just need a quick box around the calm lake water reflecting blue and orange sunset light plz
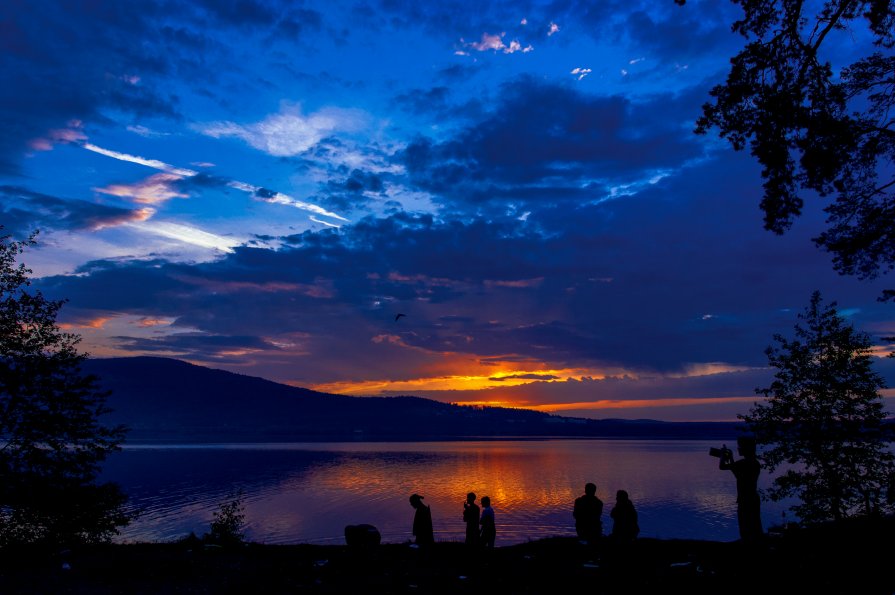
[104,440,782,545]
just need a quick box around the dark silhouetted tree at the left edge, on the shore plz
[0,228,127,544]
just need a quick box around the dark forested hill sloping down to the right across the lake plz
[84,357,736,442]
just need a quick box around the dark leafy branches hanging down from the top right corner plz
[676,0,895,284]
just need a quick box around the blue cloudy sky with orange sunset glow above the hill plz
[0,0,895,421]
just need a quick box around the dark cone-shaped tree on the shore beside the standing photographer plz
[739,292,893,522]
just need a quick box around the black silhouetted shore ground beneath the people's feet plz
[0,518,895,595]
